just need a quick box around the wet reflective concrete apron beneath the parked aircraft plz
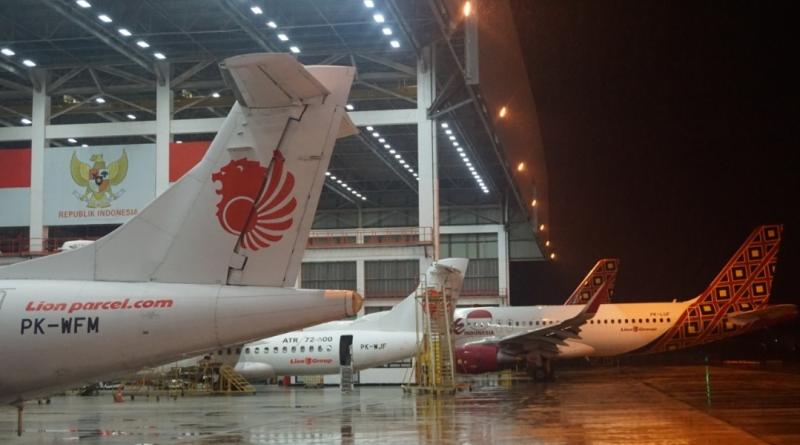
[0,366,800,445]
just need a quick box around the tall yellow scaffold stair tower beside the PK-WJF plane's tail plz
[404,276,456,394]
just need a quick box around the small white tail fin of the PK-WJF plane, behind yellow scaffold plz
[353,258,469,331]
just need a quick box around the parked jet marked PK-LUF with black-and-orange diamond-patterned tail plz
[455,225,798,378]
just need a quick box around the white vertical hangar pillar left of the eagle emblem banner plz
[28,69,50,251]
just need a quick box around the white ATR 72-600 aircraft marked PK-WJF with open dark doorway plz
[228,258,468,379]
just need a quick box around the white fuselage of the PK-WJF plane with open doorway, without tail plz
[235,322,418,379]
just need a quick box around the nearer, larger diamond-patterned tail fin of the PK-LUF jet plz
[647,224,783,352]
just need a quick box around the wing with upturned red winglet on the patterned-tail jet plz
[467,282,609,355]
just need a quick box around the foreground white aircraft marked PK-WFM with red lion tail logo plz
[0,54,361,403]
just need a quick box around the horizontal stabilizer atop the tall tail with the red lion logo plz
[222,54,330,108]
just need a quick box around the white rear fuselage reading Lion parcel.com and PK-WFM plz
[0,280,358,403]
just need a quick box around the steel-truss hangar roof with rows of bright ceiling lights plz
[0,0,546,234]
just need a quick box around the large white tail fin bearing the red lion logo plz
[0,54,354,286]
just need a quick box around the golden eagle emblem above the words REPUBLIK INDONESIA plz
[69,149,128,209]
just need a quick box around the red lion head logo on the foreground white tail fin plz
[211,150,297,250]
